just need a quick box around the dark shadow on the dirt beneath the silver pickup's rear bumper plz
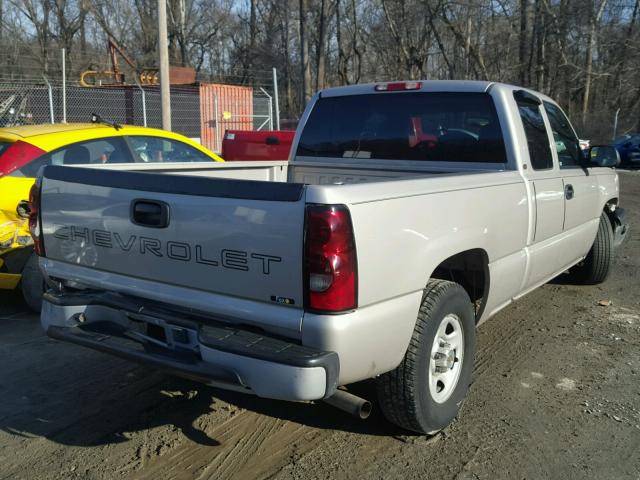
[0,290,407,452]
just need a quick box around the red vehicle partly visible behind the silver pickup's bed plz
[222,130,296,161]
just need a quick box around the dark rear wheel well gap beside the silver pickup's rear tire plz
[431,248,489,322]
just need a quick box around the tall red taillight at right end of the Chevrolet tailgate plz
[305,205,358,313]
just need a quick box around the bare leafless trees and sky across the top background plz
[0,0,640,142]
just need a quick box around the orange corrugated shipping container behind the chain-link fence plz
[200,83,253,153]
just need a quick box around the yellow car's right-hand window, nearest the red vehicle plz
[127,136,211,163]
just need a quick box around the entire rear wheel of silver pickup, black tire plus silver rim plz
[376,279,476,435]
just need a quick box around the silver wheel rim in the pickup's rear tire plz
[429,313,464,403]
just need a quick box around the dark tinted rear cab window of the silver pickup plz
[296,92,507,164]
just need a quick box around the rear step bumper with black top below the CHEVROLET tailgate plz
[41,292,340,401]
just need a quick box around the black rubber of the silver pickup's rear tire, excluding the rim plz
[376,280,476,434]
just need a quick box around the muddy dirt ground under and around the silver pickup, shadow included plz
[0,172,640,480]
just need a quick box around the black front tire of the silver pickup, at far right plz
[571,212,614,285]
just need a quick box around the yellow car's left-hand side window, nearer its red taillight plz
[20,137,131,177]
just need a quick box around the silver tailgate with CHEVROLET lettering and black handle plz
[41,166,304,311]
